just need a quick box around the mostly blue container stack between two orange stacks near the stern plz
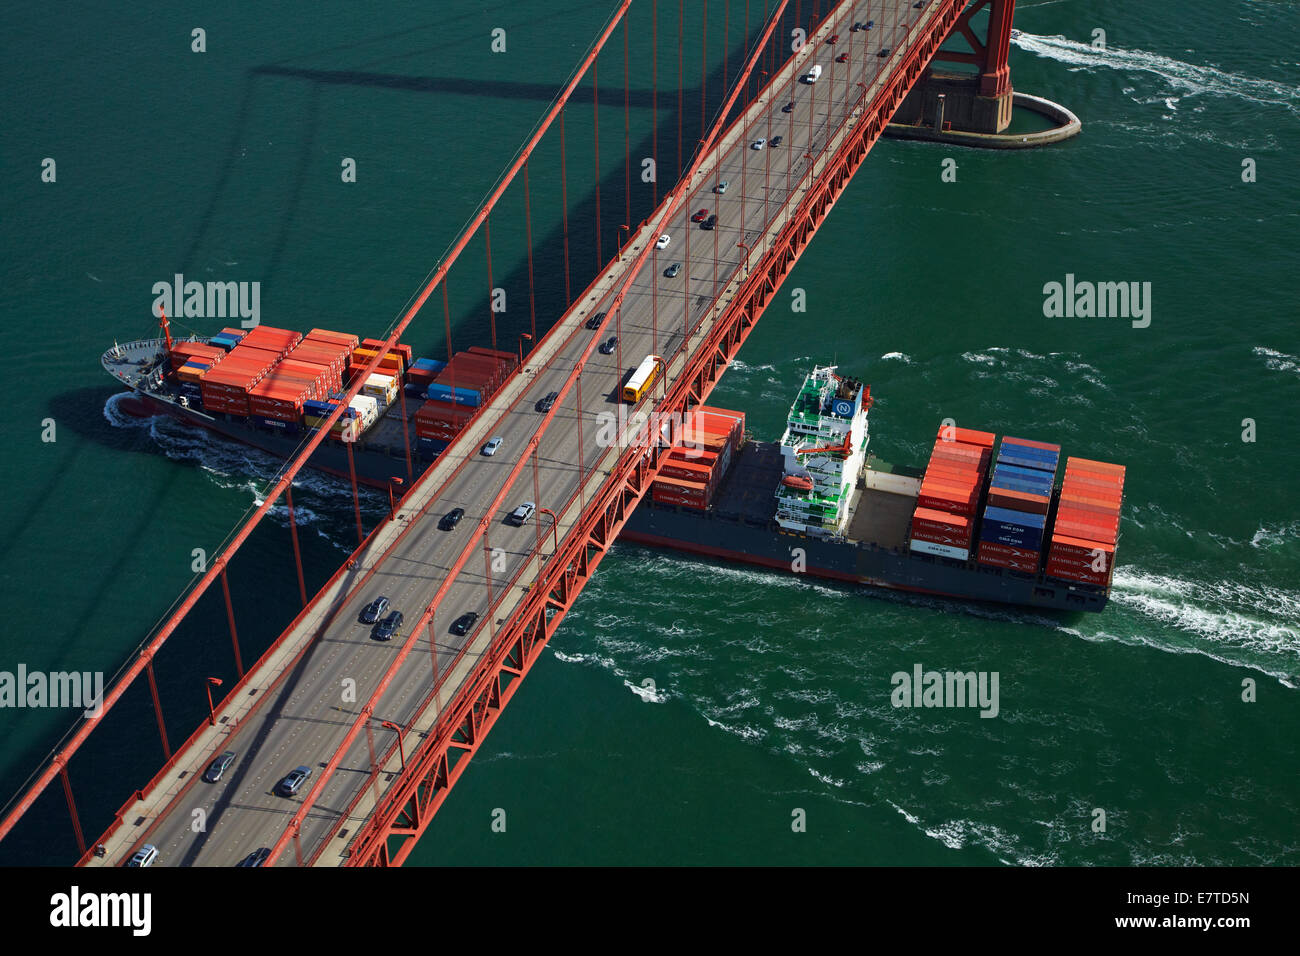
[976,437,1061,574]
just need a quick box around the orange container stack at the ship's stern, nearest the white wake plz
[1047,458,1125,587]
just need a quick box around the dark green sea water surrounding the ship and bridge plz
[0,0,1300,865]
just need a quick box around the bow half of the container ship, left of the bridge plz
[100,315,519,488]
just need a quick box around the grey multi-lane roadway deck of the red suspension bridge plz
[91,0,935,866]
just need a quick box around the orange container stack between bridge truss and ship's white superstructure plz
[650,405,745,511]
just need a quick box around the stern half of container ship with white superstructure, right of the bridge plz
[620,368,1125,611]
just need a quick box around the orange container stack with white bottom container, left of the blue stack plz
[909,425,995,561]
